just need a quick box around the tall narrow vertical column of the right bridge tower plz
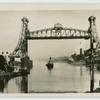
[88,16,96,92]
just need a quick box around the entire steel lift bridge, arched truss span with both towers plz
[0,16,100,92]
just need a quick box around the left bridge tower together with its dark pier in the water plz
[9,17,30,93]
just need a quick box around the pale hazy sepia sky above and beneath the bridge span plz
[0,10,100,57]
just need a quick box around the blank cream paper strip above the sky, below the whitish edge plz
[0,3,100,11]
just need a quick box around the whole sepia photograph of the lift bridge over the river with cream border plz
[0,5,100,94]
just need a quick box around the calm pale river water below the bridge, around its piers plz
[5,60,100,93]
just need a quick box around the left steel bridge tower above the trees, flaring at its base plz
[9,17,29,58]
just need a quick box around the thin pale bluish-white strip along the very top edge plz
[0,0,100,3]
